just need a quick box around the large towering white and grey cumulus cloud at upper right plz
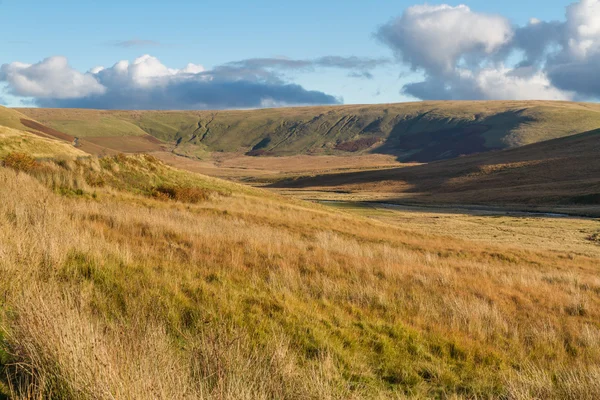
[376,0,600,100]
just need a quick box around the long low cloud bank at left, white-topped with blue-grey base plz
[0,55,339,109]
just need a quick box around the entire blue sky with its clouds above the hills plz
[0,0,600,109]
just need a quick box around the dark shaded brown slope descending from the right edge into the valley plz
[274,130,600,209]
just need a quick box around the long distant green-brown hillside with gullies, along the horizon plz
[21,101,600,161]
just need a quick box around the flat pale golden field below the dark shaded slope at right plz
[324,201,600,258]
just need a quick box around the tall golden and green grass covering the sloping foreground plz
[0,156,600,399]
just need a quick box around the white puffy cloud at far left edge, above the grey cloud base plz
[0,56,106,99]
